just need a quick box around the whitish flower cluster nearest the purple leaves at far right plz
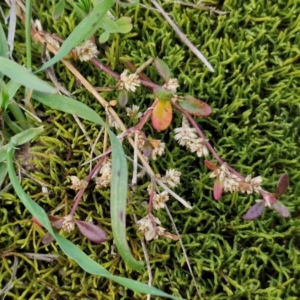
[210,163,262,194]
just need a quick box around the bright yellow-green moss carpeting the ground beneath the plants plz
[0,0,300,300]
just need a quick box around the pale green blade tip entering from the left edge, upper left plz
[0,57,56,94]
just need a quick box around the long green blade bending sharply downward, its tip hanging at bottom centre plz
[32,92,142,270]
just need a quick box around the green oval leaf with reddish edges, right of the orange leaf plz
[178,96,212,117]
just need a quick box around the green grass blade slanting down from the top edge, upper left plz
[38,0,114,72]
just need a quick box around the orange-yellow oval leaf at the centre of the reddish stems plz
[152,101,173,131]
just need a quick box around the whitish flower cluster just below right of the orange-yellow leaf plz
[174,117,209,157]
